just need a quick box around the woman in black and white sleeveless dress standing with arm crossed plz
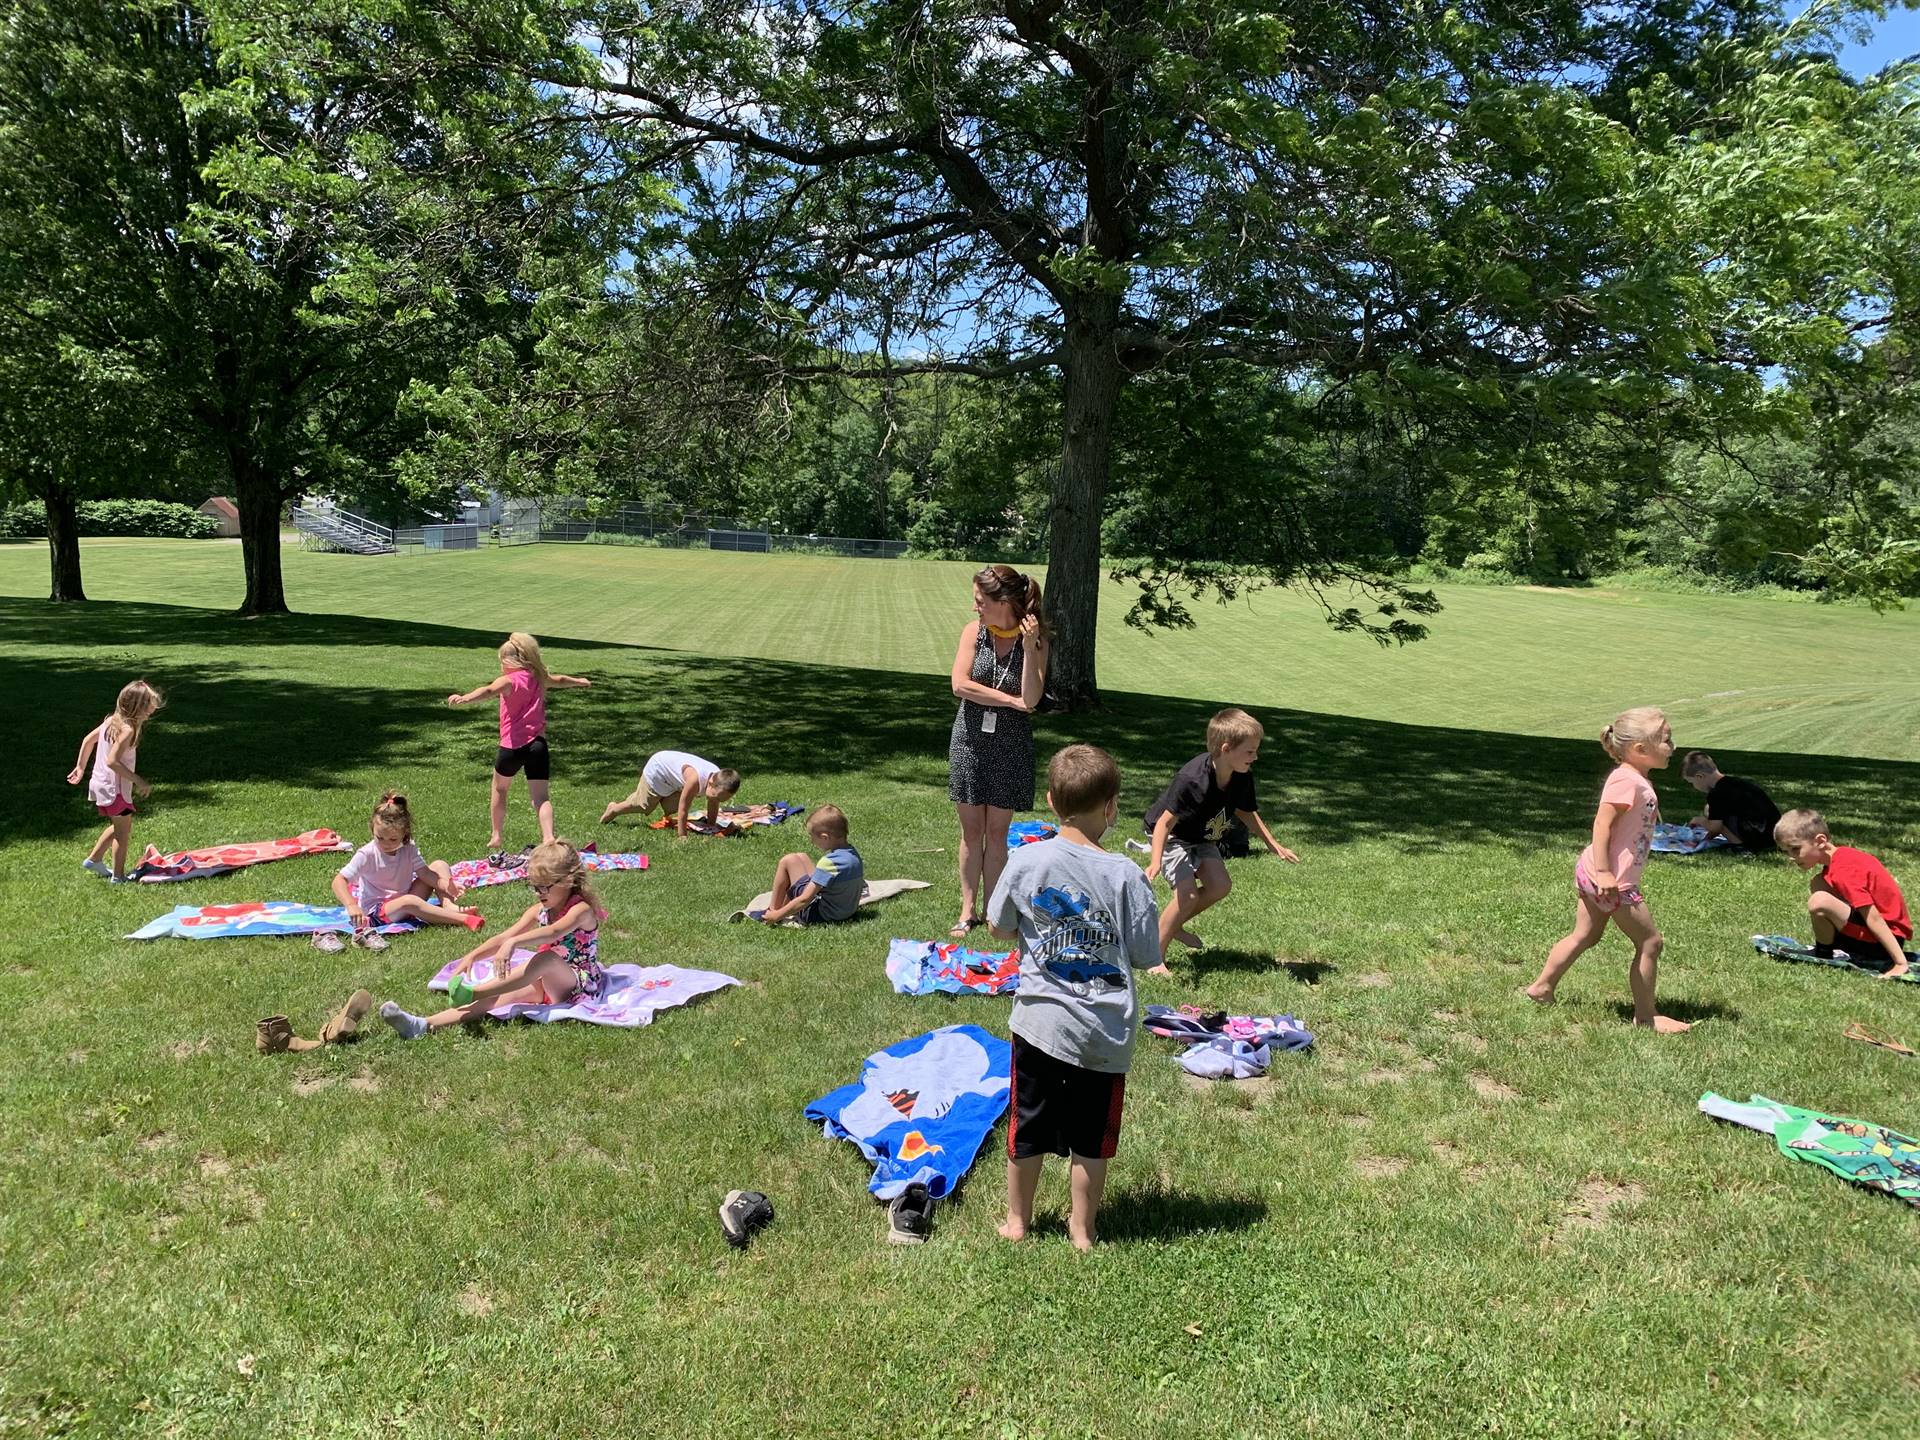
[947,564,1046,939]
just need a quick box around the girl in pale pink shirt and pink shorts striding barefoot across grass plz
[1526,705,1692,1035]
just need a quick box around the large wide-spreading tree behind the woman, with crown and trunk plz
[483,0,1904,703]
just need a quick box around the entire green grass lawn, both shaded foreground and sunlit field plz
[0,541,1920,1440]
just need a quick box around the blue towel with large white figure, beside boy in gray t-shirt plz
[806,1025,1014,1200]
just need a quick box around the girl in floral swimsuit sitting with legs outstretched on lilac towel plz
[380,839,607,1041]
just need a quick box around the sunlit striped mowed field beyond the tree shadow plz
[0,541,1920,760]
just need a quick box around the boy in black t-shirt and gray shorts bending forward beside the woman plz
[1146,710,1300,975]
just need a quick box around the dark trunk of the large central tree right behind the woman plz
[1046,296,1121,710]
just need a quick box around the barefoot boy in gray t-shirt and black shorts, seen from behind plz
[987,745,1160,1250]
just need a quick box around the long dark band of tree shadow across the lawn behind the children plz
[15,599,1920,864]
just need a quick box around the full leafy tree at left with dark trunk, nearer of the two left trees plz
[0,0,647,614]
